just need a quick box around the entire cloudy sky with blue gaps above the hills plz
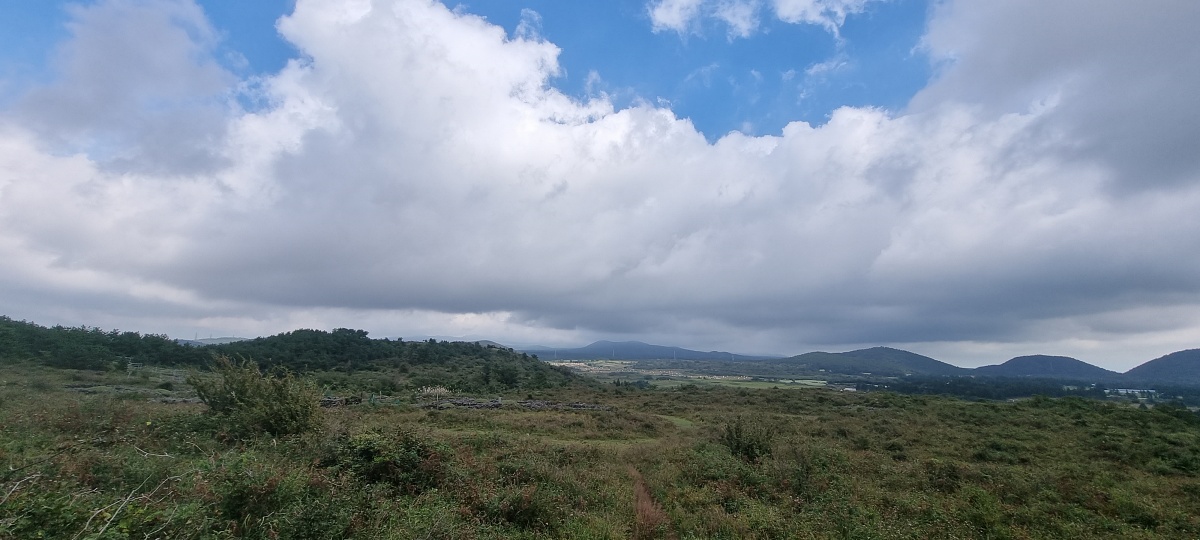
[0,0,1200,371]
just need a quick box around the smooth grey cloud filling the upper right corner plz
[912,0,1200,188]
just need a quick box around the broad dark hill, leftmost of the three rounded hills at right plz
[778,347,968,377]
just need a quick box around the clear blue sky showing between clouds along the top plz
[0,0,931,140]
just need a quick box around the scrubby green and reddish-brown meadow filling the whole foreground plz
[0,352,1200,539]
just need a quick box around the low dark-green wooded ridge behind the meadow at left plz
[0,316,580,392]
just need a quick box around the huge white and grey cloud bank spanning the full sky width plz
[0,0,1200,361]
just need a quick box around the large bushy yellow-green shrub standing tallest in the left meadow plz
[187,355,320,434]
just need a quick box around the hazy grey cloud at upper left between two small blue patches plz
[13,0,234,174]
